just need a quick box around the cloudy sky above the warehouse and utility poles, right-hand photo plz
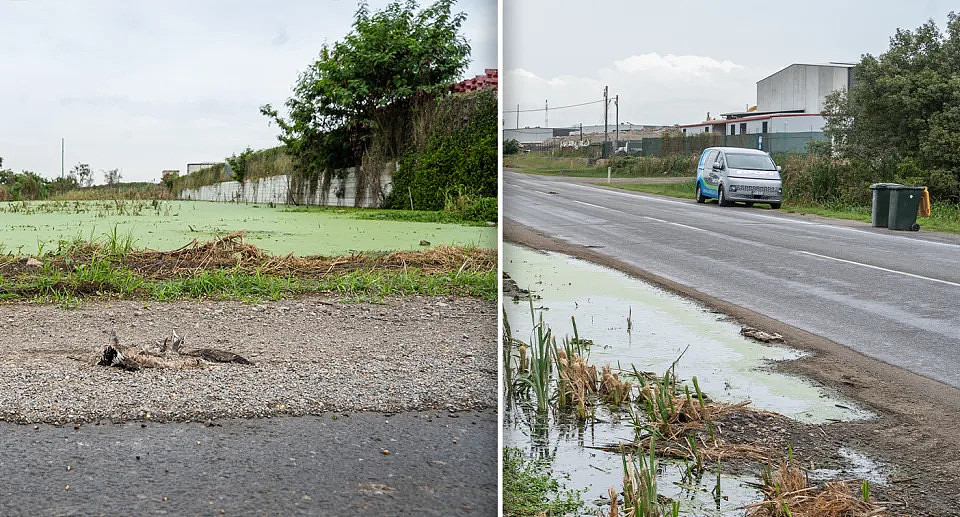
[501,0,960,128]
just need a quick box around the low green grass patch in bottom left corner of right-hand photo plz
[503,447,584,517]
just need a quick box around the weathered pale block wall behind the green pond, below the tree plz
[179,163,396,207]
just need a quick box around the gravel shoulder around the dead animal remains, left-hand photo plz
[0,296,497,424]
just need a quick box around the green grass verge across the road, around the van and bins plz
[611,181,960,233]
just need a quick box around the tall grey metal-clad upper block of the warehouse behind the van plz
[757,64,850,113]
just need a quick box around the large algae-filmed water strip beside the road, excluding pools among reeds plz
[503,244,872,423]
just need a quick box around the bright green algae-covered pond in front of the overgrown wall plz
[0,201,497,256]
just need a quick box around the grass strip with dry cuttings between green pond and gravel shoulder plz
[0,258,497,307]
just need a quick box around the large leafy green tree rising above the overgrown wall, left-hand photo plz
[260,0,470,179]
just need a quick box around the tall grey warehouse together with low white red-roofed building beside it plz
[677,63,854,135]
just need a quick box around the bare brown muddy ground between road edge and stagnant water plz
[503,220,960,516]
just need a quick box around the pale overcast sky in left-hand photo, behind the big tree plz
[0,0,497,183]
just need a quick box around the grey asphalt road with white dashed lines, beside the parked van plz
[503,171,960,387]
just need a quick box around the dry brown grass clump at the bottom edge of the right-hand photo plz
[745,461,888,517]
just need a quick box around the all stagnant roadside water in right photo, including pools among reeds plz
[503,244,883,516]
